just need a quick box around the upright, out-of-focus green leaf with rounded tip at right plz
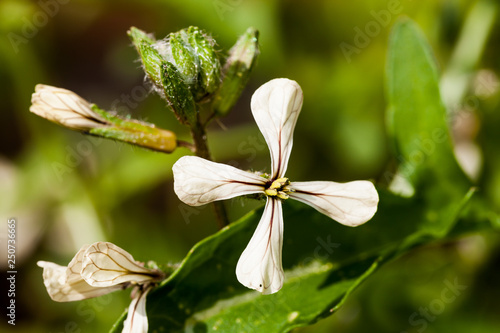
[386,19,471,237]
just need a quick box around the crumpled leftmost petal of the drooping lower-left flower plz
[37,245,121,302]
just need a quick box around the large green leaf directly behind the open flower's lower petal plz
[111,191,476,332]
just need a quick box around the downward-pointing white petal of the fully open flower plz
[236,198,284,294]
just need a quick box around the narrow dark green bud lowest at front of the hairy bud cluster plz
[161,61,197,125]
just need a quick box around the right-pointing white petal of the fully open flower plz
[289,180,378,227]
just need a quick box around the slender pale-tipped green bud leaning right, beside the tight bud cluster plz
[212,28,259,116]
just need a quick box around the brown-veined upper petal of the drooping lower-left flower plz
[81,242,161,287]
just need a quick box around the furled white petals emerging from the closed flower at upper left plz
[30,84,108,131]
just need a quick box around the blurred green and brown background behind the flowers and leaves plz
[0,0,500,332]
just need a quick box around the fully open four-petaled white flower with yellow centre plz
[173,79,378,294]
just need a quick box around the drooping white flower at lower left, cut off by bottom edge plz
[37,242,165,333]
